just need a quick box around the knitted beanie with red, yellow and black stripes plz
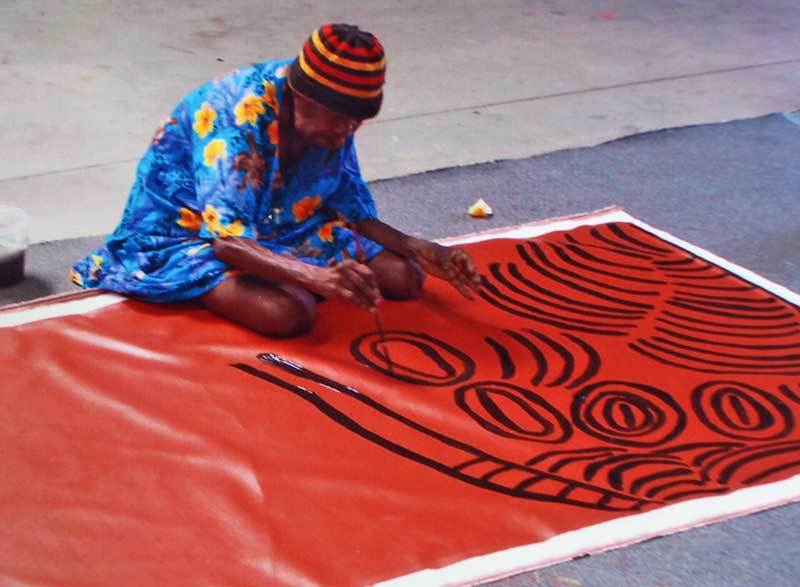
[289,24,386,119]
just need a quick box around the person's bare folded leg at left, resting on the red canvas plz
[201,275,317,337]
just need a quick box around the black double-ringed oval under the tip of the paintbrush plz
[350,330,475,386]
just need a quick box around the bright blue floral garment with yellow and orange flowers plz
[72,60,382,302]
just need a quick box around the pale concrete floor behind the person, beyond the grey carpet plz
[0,0,800,241]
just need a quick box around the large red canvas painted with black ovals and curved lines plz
[0,212,800,586]
